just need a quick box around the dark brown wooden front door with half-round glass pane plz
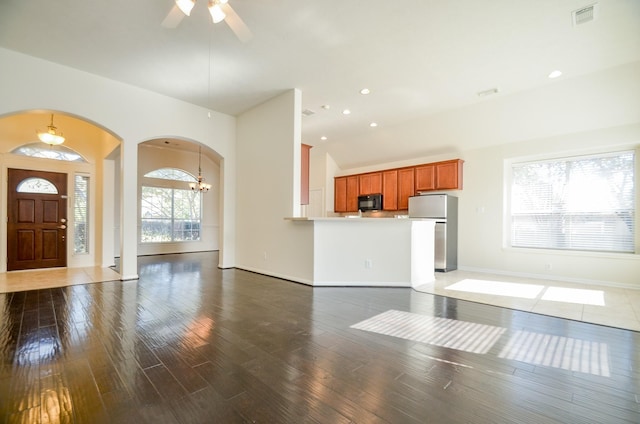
[7,169,67,271]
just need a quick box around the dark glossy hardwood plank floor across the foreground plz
[0,253,640,424]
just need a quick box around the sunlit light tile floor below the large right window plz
[416,270,640,331]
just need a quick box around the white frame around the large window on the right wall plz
[502,144,640,258]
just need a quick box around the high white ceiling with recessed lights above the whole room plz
[0,0,640,166]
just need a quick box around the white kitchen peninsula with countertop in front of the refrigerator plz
[285,217,435,287]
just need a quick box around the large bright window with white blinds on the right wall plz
[511,151,636,253]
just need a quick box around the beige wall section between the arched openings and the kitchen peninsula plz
[236,89,313,283]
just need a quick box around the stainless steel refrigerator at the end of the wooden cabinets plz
[409,194,458,272]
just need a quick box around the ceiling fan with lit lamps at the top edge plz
[162,0,253,43]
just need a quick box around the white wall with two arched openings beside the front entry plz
[0,49,235,279]
